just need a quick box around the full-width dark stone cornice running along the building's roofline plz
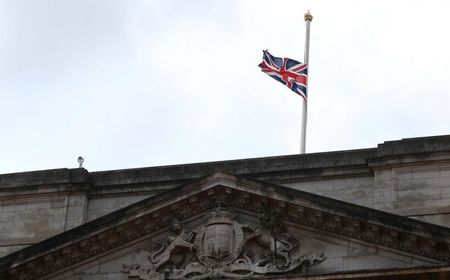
[0,135,450,197]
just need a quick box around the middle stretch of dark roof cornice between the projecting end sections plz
[91,149,376,187]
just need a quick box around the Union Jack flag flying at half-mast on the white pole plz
[258,50,308,101]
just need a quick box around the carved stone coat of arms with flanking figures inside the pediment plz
[123,206,325,280]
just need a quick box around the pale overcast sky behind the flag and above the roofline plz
[0,0,450,173]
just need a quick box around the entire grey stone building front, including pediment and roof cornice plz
[0,136,450,280]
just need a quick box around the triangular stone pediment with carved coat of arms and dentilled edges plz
[0,173,450,280]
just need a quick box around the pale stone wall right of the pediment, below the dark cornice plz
[283,163,450,226]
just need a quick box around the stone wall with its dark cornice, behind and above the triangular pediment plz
[0,136,450,257]
